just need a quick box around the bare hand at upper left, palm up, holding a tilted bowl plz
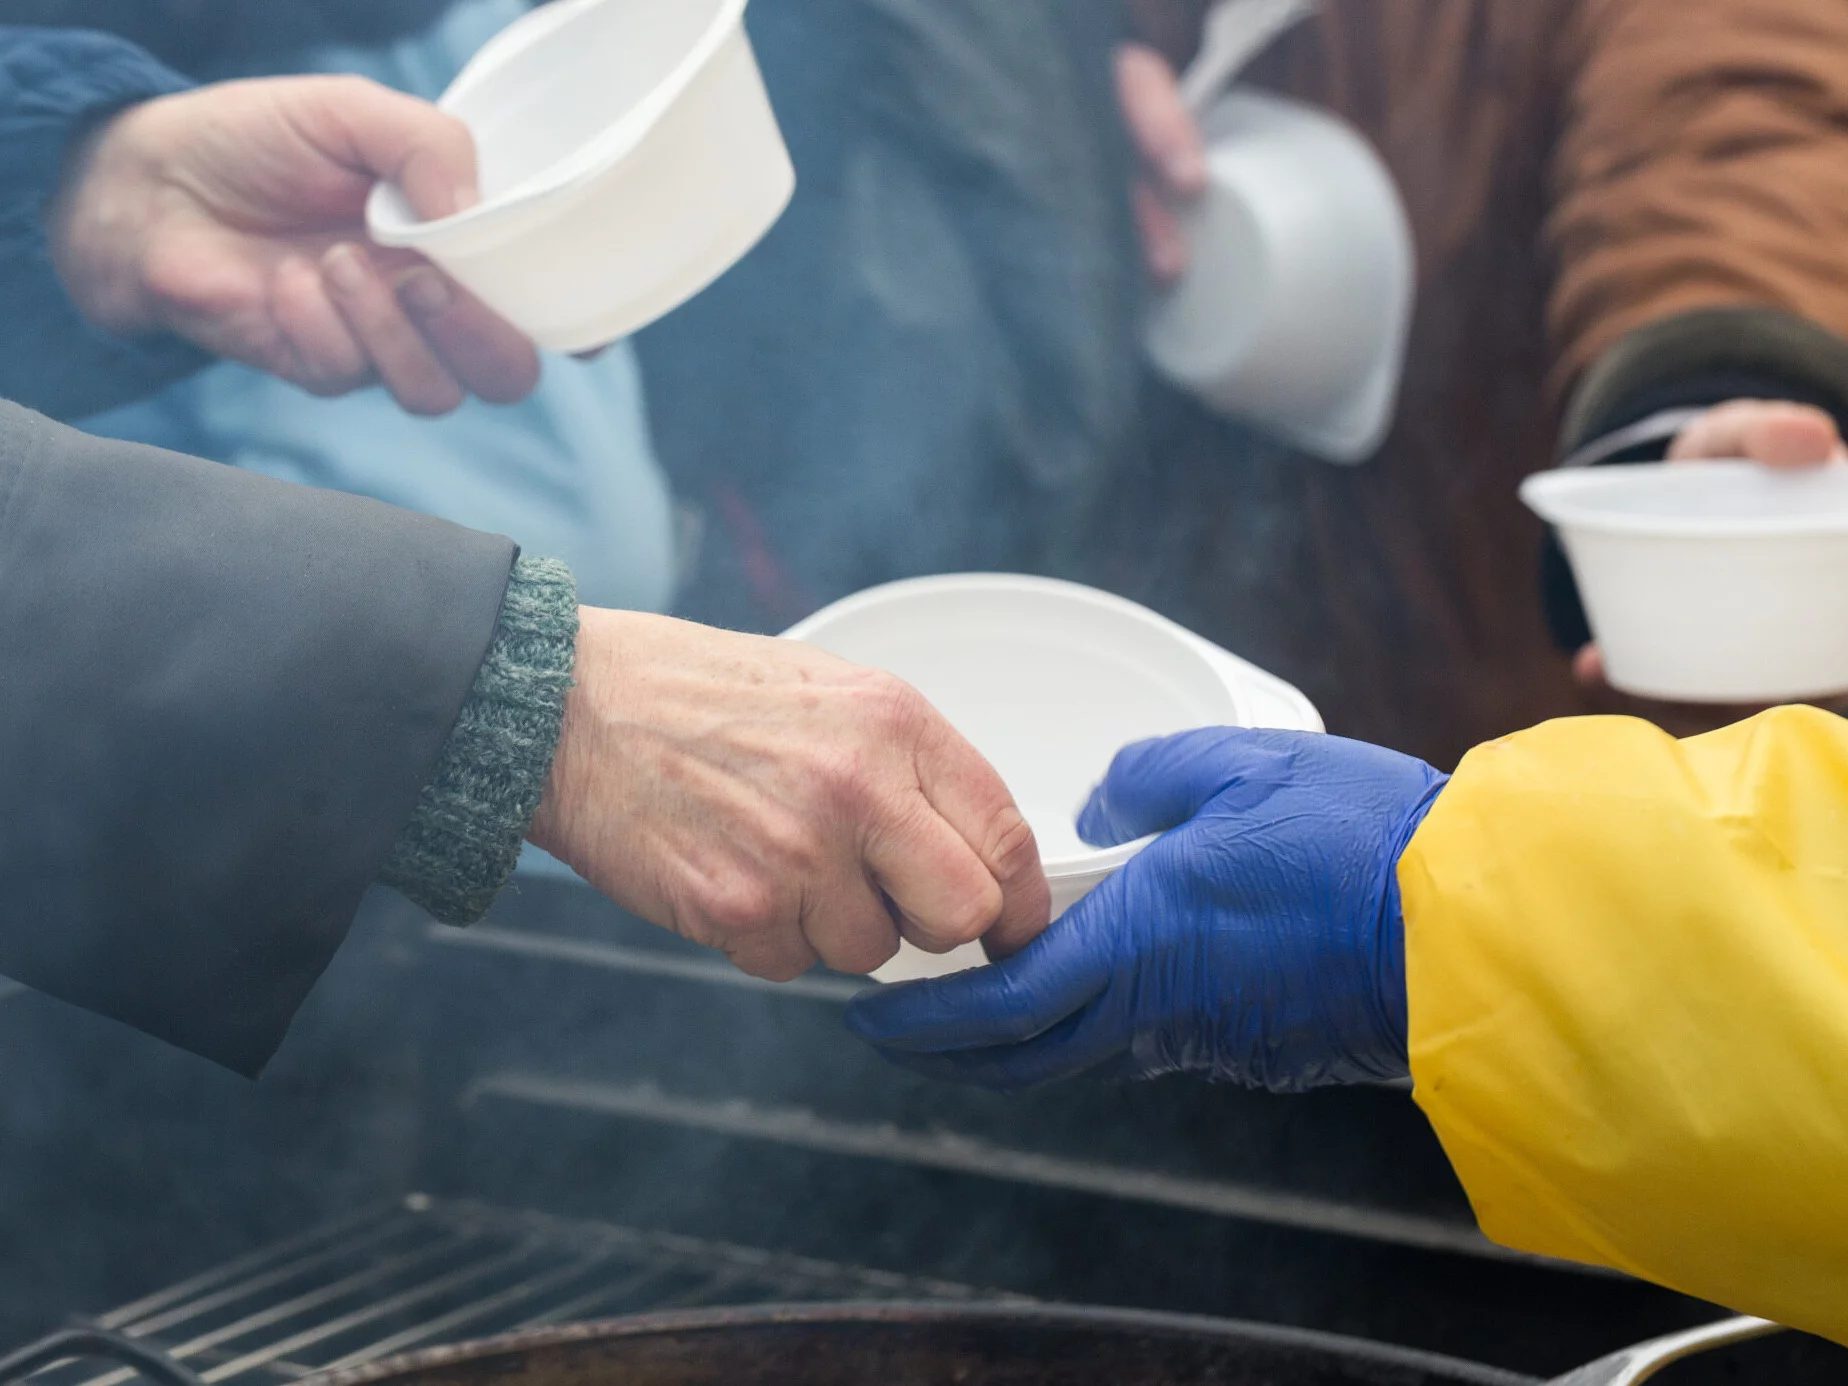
[48,78,540,414]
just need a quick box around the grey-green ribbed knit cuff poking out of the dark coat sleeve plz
[379,558,577,924]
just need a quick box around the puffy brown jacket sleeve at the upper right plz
[1545,0,1848,434]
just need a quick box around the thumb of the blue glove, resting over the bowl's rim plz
[1077,726,1288,846]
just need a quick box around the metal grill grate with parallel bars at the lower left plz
[31,1194,1016,1386]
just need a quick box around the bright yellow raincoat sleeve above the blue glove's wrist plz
[1399,708,1848,1342]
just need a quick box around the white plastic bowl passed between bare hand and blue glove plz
[785,573,1321,981]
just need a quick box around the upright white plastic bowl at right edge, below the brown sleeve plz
[1521,462,1848,702]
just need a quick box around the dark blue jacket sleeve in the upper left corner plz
[0,26,209,419]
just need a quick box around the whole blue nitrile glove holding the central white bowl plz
[846,728,1447,1092]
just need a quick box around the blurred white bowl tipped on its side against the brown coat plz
[1146,91,1416,462]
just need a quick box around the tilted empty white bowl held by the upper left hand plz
[366,0,795,351]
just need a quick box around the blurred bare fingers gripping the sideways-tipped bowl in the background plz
[1116,43,1207,283]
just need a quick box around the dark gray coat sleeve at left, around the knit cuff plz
[0,405,516,1074]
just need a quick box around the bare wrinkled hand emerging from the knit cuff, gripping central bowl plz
[529,608,1050,981]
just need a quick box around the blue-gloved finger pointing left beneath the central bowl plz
[846,901,1120,1053]
